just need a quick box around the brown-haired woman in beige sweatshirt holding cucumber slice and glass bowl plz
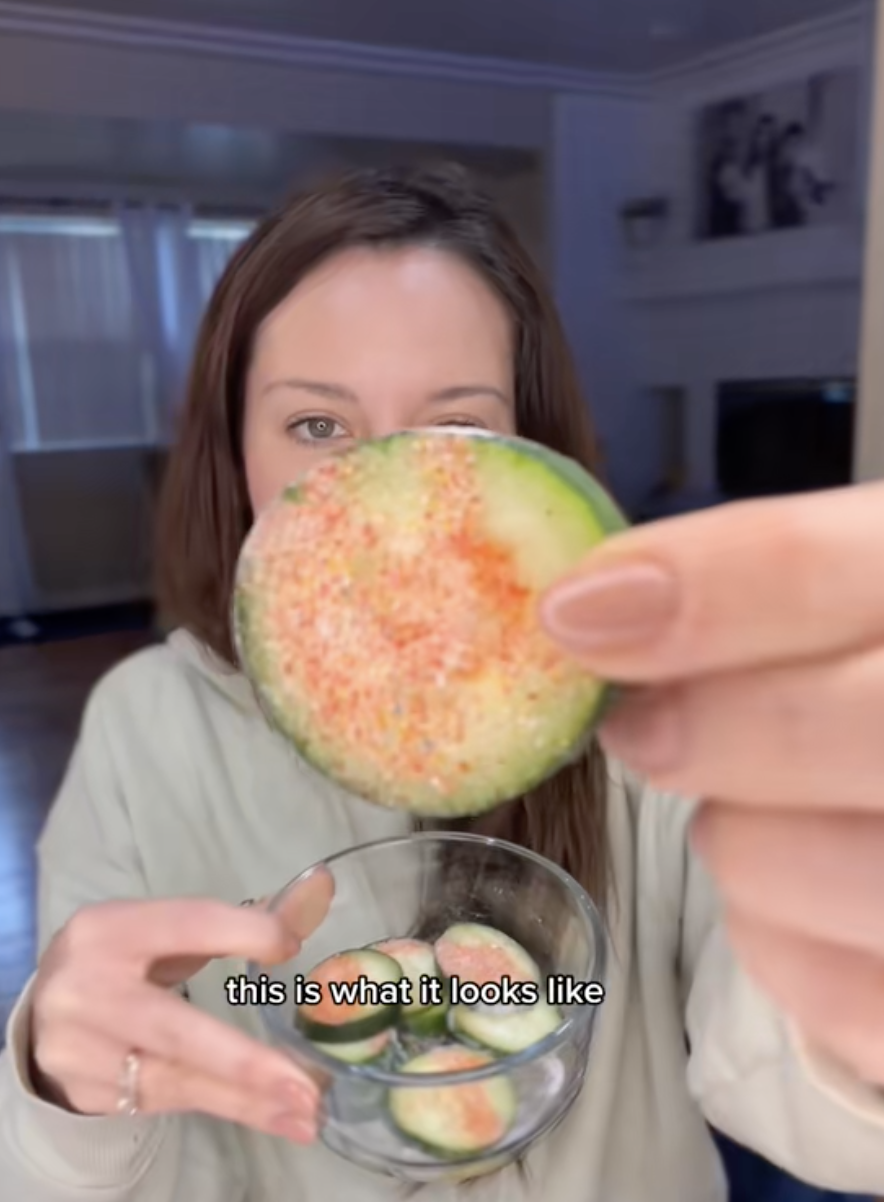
[0,162,884,1202]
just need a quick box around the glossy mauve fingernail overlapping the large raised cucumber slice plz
[542,564,678,650]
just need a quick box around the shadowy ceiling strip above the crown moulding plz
[17,0,872,72]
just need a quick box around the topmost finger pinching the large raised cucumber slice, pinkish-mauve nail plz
[541,484,884,684]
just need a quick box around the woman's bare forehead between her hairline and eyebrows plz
[248,248,511,377]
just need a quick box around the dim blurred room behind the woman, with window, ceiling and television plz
[0,0,876,1200]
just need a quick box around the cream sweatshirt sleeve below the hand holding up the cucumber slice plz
[664,783,884,1197]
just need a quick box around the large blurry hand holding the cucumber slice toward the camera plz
[542,484,884,1085]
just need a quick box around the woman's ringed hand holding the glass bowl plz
[31,873,331,1143]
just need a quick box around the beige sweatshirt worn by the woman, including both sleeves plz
[0,633,884,1202]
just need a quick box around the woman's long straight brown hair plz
[158,166,609,910]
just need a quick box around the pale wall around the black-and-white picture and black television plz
[538,12,884,508]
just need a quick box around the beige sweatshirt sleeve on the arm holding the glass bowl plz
[0,680,243,1202]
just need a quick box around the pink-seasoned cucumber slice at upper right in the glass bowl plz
[433,922,540,1008]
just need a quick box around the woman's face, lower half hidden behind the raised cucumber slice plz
[244,248,515,512]
